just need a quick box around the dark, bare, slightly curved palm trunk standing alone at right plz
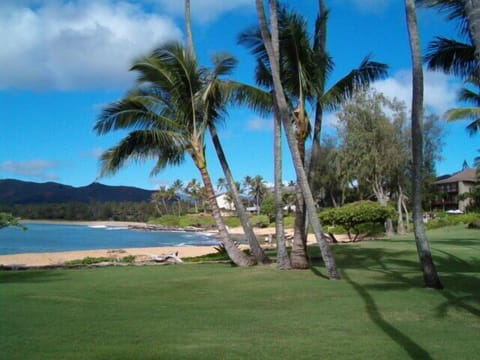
[405,0,443,289]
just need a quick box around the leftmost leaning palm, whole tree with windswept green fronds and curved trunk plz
[94,42,255,266]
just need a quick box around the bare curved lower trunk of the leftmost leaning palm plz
[198,166,255,266]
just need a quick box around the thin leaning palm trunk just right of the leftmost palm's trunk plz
[209,124,270,264]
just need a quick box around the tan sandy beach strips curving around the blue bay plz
[0,220,288,266]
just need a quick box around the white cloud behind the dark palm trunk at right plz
[373,70,461,116]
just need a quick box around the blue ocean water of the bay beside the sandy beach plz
[0,224,218,255]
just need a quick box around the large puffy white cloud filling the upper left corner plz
[0,0,182,90]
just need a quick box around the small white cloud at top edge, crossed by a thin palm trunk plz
[151,0,255,23]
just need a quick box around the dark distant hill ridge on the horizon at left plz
[0,179,154,205]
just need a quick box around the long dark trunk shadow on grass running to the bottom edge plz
[341,271,432,360]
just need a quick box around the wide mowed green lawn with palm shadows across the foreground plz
[0,226,480,360]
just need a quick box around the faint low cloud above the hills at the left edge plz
[0,160,59,180]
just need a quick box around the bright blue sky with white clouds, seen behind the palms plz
[0,0,479,189]
